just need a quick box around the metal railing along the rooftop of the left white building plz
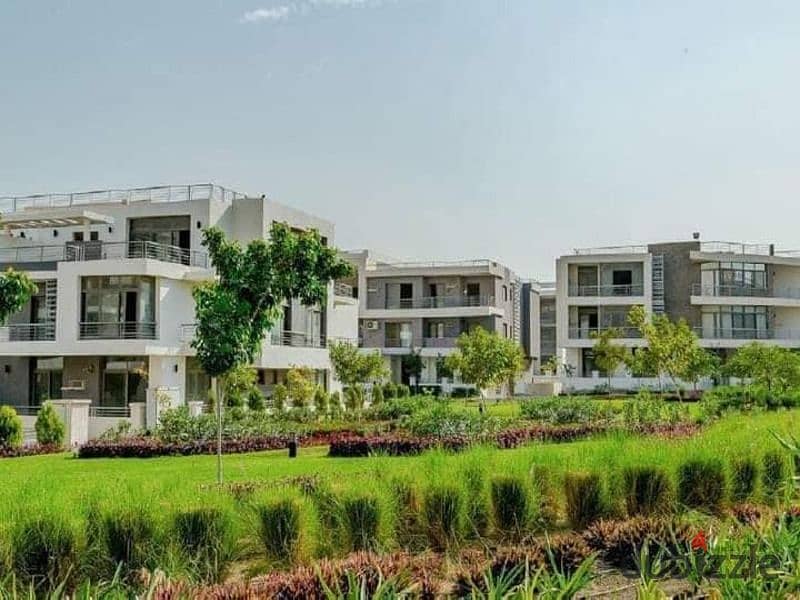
[0,183,245,214]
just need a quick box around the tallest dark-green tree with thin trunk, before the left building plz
[192,223,352,483]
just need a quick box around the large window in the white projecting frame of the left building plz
[81,275,156,339]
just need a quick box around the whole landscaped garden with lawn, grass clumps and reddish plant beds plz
[0,387,800,598]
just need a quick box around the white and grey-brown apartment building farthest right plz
[556,239,800,377]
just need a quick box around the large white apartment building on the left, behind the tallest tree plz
[0,184,358,433]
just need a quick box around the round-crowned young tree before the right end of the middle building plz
[445,327,525,397]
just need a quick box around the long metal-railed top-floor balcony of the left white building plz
[0,241,209,268]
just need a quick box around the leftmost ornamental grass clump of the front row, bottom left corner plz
[11,515,77,590]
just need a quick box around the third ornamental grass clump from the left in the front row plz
[174,508,234,582]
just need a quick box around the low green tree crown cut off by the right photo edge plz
[724,342,800,392]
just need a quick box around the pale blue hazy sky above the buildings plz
[0,0,800,278]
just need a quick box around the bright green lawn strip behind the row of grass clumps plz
[0,411,800,523]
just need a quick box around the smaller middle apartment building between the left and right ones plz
[345,250,539,385]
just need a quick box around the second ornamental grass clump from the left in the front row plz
[103,507,156,574]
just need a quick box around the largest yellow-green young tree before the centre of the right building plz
[628,306,699,399]
